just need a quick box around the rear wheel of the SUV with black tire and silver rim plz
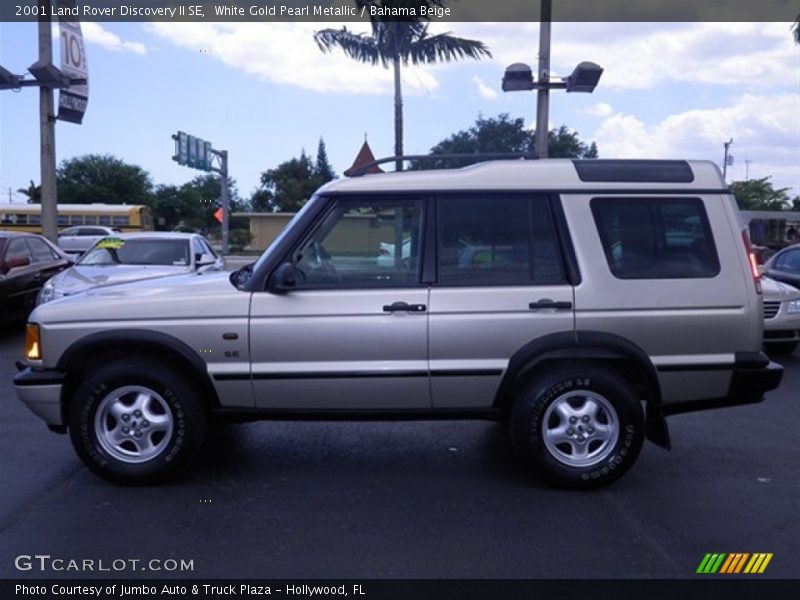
[510,366,644,489]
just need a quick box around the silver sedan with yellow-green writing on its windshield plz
[37,232,225,304]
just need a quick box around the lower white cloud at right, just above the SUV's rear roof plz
[592,94,800,193]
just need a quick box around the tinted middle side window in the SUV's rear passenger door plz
[437,196,565,285]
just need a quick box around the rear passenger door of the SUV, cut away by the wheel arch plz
[429,194,574,408]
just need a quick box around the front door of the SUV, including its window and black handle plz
[250,196,431,411]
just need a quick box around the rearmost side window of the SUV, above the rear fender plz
[591,198,719,279]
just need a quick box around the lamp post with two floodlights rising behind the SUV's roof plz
[503,0,603,158]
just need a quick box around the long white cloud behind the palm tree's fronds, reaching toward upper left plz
[147,23,439,94]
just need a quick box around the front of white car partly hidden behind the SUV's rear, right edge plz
[761,277,800,354]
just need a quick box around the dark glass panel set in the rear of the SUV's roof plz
[572,160,694,183]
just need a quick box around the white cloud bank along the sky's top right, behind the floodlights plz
[458,22,800,90]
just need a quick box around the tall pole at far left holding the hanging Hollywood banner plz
[39,15,58,243]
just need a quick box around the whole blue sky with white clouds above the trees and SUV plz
[0,23,800,202]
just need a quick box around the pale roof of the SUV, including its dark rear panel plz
[320,159,727,193]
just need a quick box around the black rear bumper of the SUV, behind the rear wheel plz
[661,352,783,416]
